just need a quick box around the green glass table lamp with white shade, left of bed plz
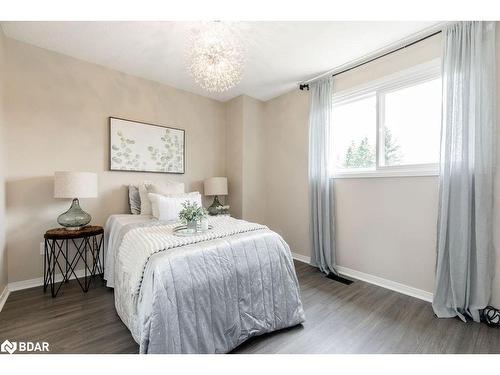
[54,172,97,230]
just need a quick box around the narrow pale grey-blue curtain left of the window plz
[309,78,337,274]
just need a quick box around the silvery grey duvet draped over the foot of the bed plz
[137,230,304,353]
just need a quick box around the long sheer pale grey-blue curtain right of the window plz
[433,22,496,321]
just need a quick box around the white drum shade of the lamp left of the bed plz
[54,172,97,199]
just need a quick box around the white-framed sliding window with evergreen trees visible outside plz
[331,61,441,177]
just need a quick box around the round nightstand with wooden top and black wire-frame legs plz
[43,226,104,297]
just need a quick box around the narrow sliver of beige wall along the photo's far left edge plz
[0,27,7,294]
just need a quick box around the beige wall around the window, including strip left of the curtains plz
[266,38,440,292]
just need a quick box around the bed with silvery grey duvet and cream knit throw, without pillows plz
[104,215,305,353]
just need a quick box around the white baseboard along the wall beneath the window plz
[292,253,432,302]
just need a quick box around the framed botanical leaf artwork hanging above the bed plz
[109,117,186,174]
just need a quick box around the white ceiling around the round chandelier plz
[1,21,436,101]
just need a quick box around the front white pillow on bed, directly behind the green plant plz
[148,191,202,221]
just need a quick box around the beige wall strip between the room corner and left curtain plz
[265,90,310,256]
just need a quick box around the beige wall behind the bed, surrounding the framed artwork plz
[5,39,226,282]
